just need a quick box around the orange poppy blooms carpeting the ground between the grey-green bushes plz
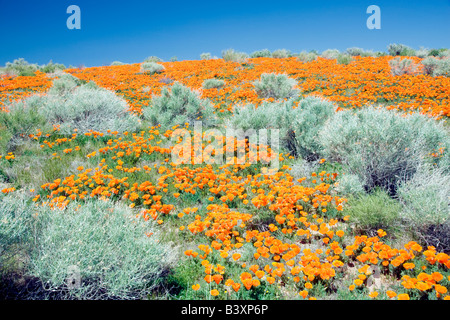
[0,52,450,300]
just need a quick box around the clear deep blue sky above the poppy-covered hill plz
[0,0,450,66]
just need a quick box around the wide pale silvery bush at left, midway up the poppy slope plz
[44,85,139,134]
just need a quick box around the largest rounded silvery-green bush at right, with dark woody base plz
[319,107,449,193]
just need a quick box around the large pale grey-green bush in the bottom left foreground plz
[29,201,175,299]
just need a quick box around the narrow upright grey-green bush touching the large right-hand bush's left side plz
[291,97,336,161]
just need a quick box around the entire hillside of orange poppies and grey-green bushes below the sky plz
[0,50,450,300]
